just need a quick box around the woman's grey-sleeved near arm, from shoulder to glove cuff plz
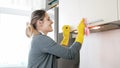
[35,36,81,59]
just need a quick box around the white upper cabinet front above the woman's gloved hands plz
[59,0,118,32]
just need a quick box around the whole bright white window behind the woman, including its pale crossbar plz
[0,0,45,67]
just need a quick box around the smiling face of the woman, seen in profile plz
[39,13,53,33]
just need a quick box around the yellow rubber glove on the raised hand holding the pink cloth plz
[75,18,85,44]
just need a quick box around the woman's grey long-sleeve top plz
[28,33,81,68]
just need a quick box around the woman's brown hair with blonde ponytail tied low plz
[26,10,46,37]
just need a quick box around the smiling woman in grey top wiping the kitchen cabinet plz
[26,10,84,68]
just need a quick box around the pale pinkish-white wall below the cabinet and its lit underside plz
[80,29,120,68]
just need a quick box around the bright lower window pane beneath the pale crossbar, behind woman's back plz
[0,14,30,67]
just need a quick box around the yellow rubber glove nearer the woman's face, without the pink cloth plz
[61,25,70,46]
